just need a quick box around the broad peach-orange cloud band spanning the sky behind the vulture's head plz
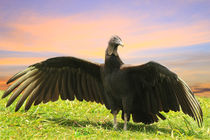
[0,14,210,58]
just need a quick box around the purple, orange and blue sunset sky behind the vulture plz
[0,0,210,95]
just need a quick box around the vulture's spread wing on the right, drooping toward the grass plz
[122,62,203,126]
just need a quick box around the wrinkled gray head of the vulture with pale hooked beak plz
[107,35,124,56]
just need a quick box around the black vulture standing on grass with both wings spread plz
[2,35,203,130]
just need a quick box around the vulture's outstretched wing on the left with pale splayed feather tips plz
[2,57,107,111]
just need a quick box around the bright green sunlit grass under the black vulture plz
[0,91,210,139]
